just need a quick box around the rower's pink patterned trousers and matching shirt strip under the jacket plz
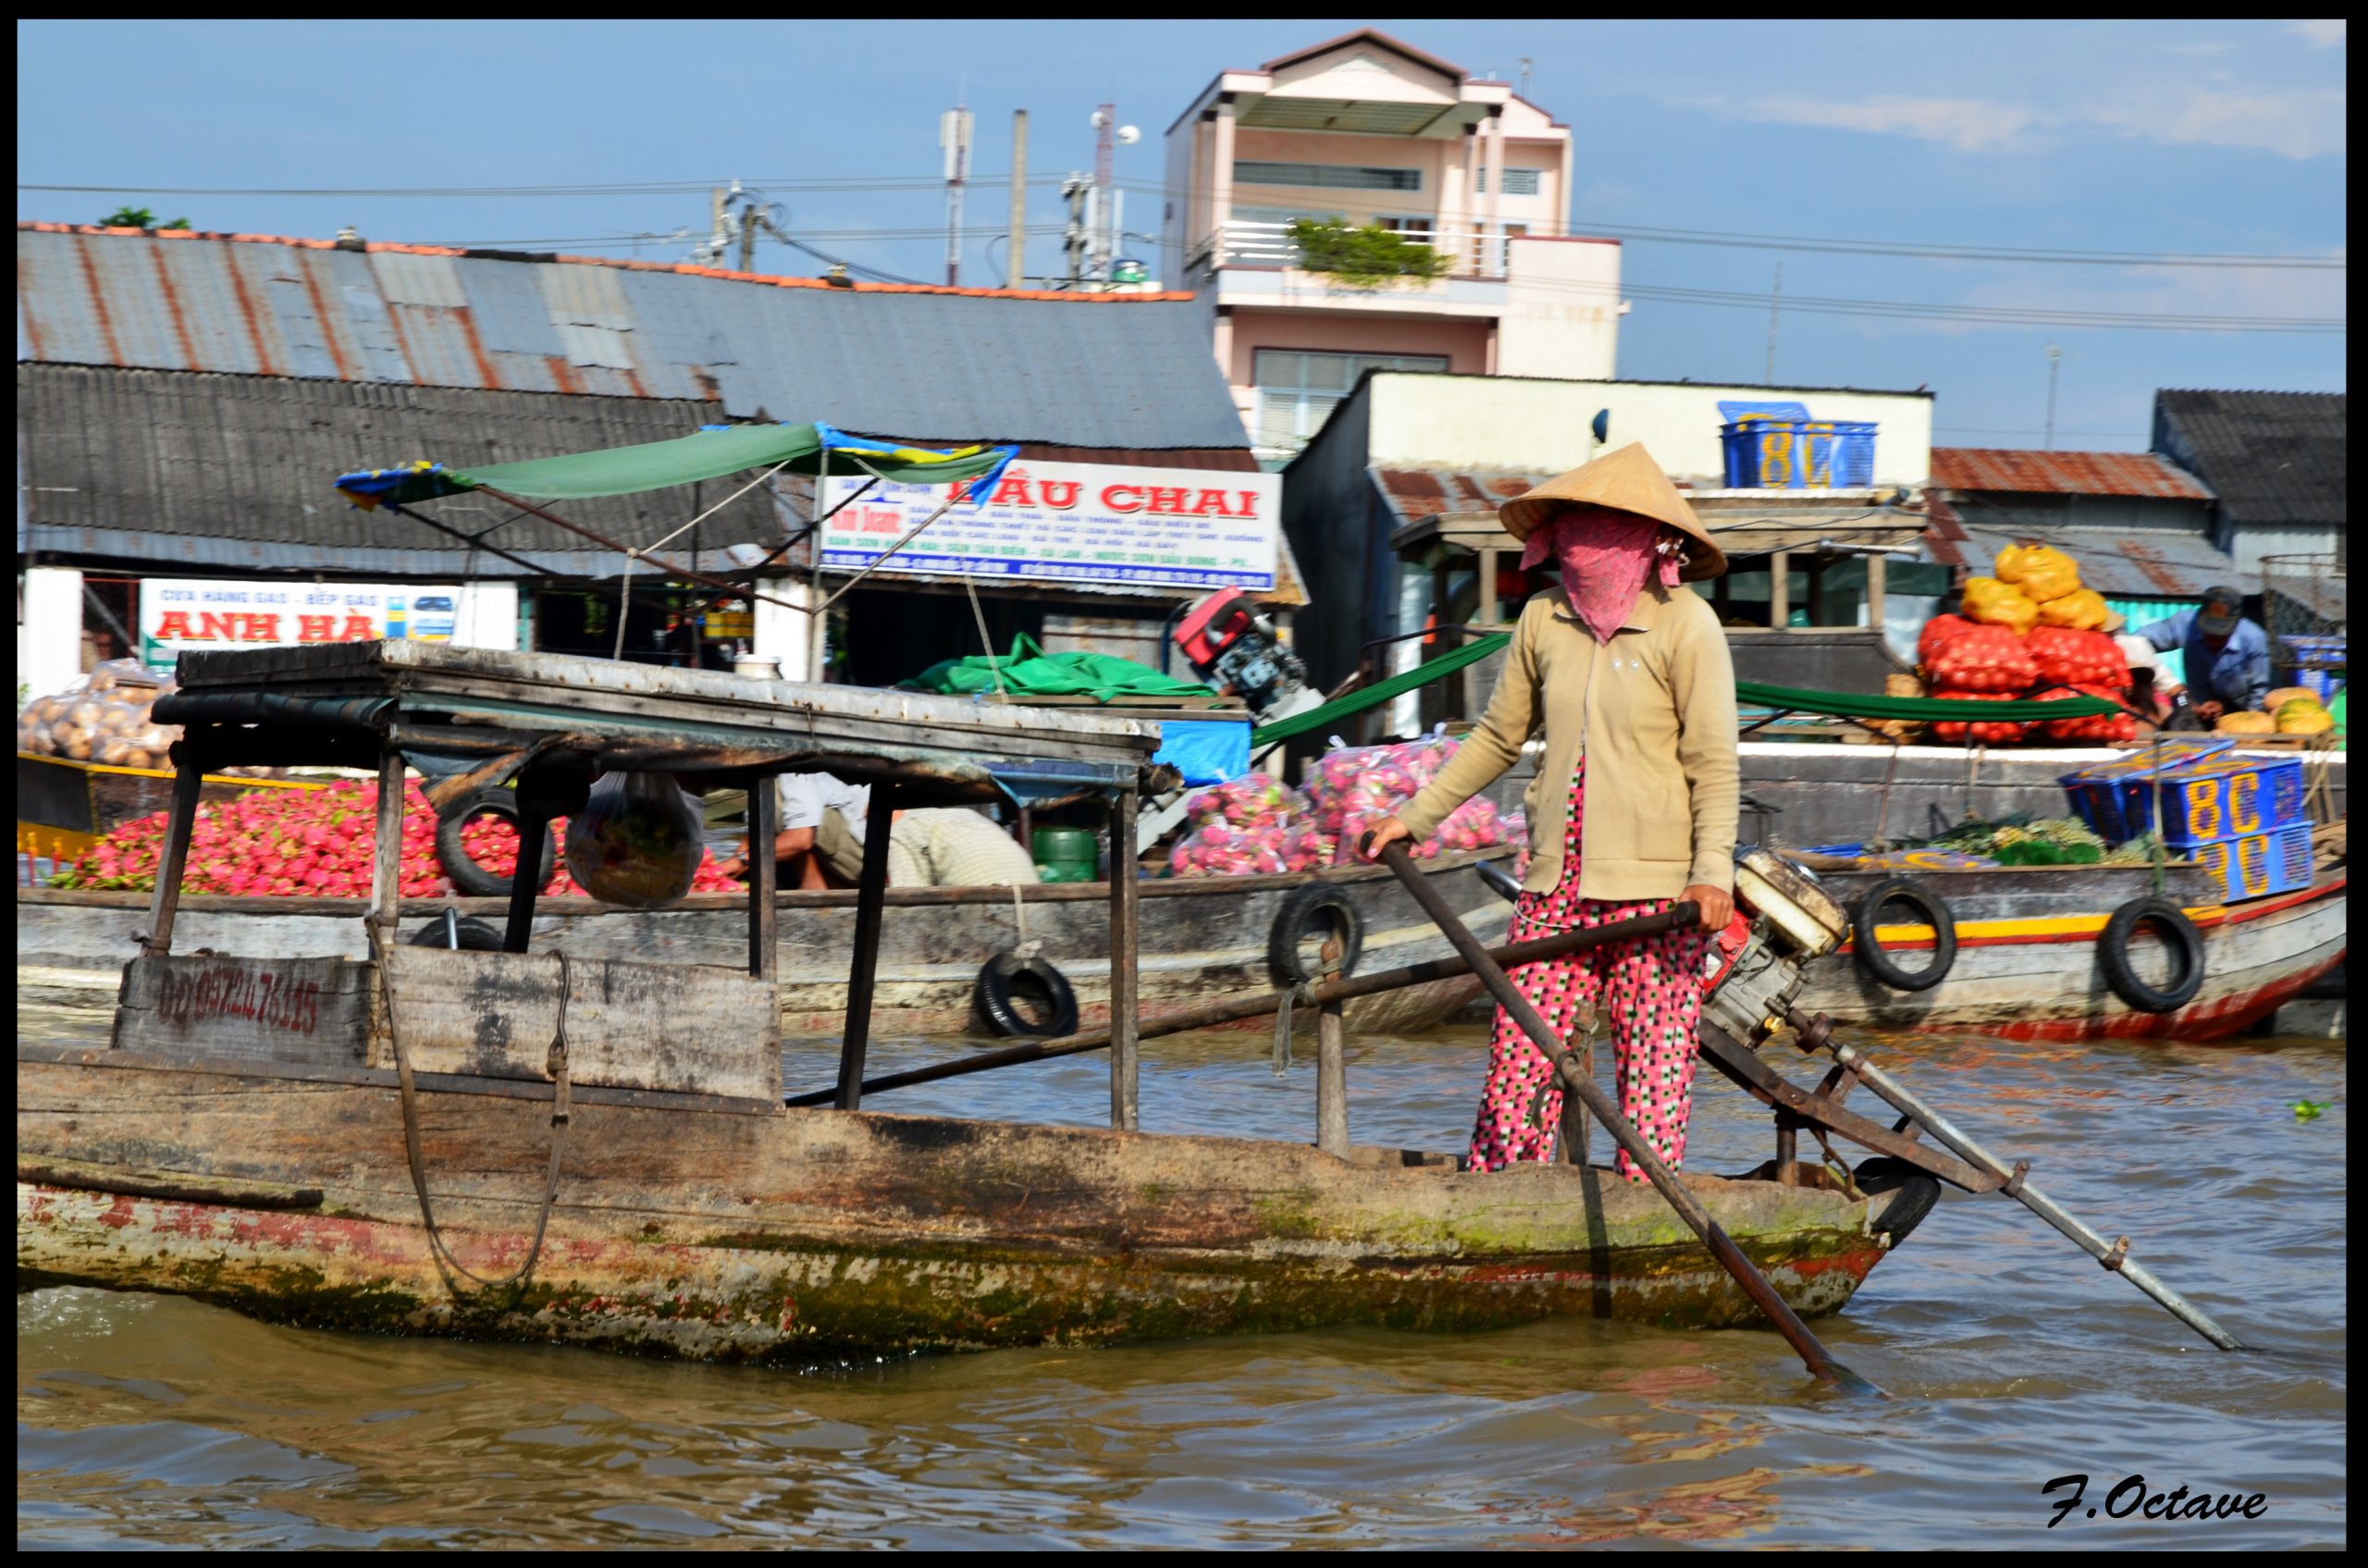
[1471,758,1709,1182]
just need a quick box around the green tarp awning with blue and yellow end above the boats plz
[337,424,1018,512]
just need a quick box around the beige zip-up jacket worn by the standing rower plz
[1397,583,1741,903]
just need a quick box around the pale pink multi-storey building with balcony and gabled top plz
[1160,29,1627,462]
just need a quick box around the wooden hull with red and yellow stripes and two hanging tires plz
[1800,876,2347,1040]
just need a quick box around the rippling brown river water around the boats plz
[17,1011,2347,1549]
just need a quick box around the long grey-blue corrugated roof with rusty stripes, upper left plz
[17,223,1248,452]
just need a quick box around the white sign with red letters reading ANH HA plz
[140,578,462,673]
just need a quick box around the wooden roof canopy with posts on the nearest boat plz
[144,642,1172,1132]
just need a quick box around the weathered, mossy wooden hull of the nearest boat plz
[17,1047,1935,1362]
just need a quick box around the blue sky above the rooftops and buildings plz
[17,19,2347,450]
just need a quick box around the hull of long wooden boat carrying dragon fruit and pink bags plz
[17,850,1511,1037]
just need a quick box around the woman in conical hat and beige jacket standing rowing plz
[1371,445,1741,1182]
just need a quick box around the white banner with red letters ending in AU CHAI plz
[821,462,1284,590]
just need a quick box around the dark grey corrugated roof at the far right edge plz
[2155,390,2351,528]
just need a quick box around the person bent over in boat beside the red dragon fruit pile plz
[722,772,1042,891]
